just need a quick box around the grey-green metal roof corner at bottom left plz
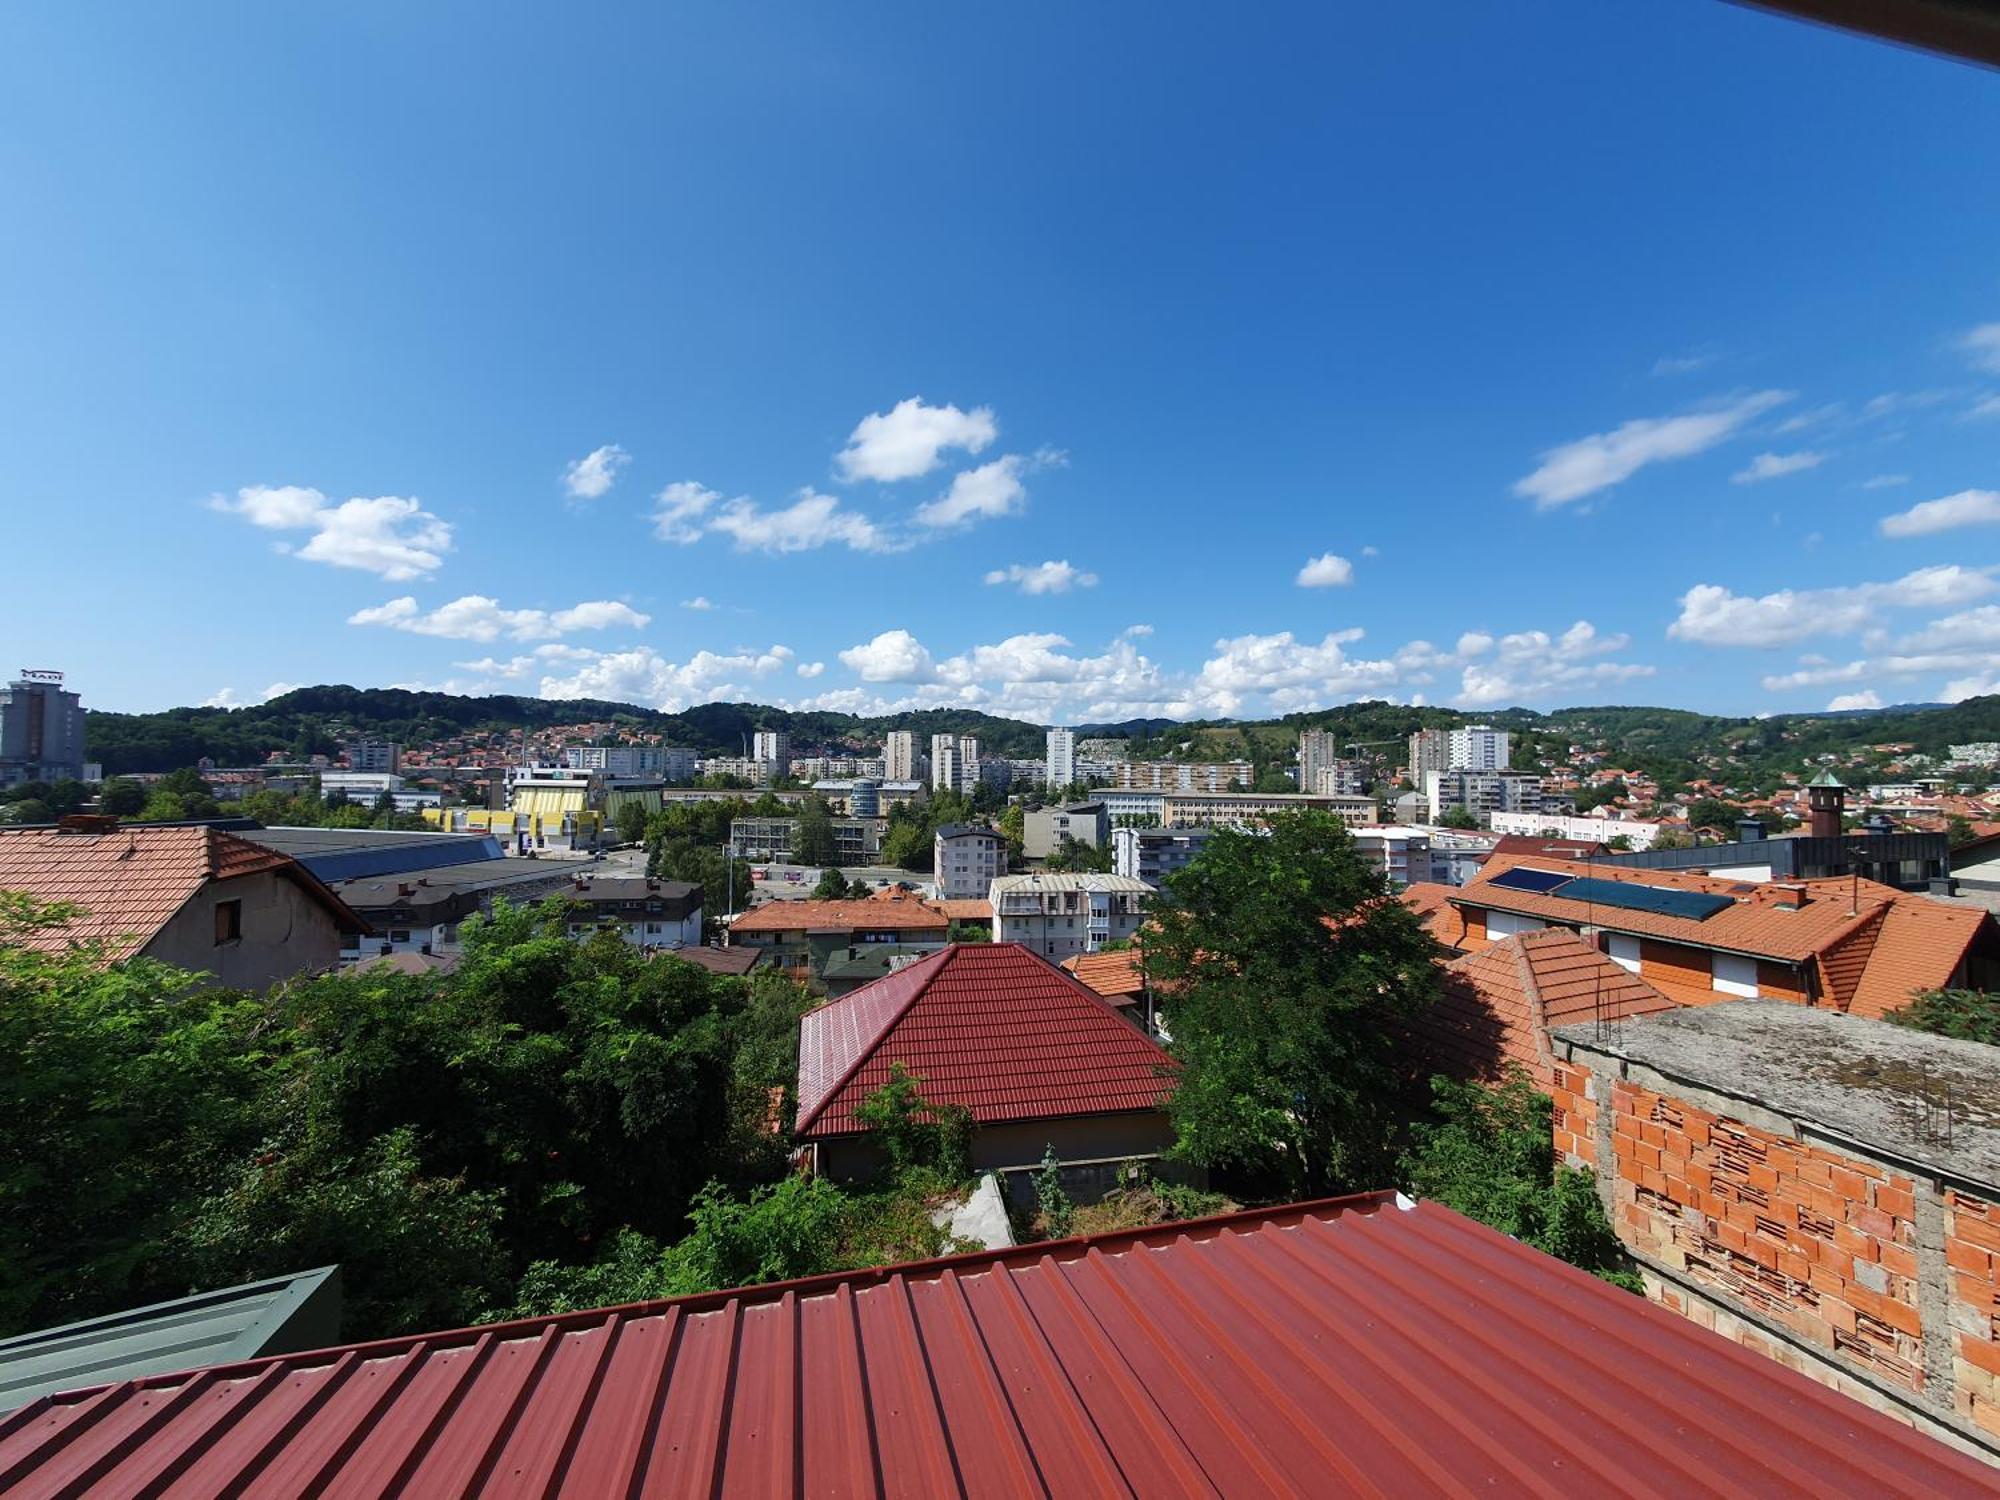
[0,1266,340,1412]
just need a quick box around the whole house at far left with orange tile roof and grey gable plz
[0,816,364,990]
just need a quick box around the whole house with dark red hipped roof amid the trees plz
[792,942,1174,1198]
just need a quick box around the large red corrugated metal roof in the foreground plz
[0,1194,2000,1500]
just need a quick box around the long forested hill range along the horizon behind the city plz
[86,686,2000,780]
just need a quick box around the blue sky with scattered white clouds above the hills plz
[0,0,2000,722]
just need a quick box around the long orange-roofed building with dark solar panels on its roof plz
[1430,854,2000,1016]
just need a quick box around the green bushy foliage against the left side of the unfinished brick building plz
[1400,1068,1640,1292]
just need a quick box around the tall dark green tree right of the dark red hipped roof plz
[1146,812,1438,1198]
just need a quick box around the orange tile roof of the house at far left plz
[0,824,368,958]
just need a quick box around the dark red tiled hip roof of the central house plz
[798,942,1172,1140]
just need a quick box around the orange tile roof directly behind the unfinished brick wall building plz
[1420,928,1680,1088]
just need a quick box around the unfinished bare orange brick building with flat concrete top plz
[1550,1000,2000,1464]
